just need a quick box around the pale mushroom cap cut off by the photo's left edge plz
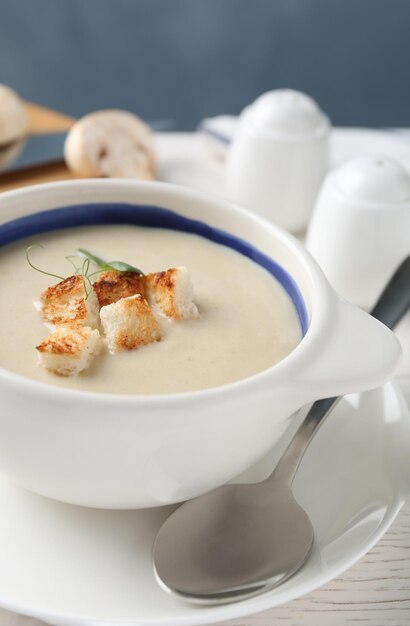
[0,84,28,146]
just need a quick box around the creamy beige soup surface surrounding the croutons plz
[0,225,301,394]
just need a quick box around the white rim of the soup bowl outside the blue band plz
[0,178,332,408]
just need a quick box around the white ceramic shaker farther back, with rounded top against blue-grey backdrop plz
[226,89,330,232]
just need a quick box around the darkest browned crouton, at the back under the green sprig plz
[93,270,145,307]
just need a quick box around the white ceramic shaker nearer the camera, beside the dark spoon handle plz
[306,157,410,382]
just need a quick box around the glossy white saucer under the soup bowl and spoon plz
[0,383,410,626]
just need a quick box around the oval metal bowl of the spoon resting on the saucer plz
[153,476,314,604]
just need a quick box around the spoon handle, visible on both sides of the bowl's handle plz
[267,256,410,484]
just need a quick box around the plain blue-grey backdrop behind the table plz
[0,0,410,129]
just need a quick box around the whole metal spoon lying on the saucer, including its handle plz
[153,256,410,604]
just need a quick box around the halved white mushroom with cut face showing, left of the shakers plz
[64,110,155,180]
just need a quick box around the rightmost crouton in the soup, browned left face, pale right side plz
[145,267,199,320]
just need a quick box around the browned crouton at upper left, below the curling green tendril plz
[41,274,99,328]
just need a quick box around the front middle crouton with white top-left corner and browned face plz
[100,294,161,354]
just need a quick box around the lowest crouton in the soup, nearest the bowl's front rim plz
[36,325,102,376]
